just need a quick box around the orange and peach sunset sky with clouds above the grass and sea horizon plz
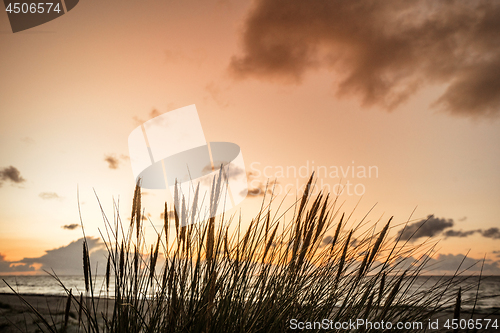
[0,0,500,275]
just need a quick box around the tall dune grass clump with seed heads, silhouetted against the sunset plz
[3,172,480,333]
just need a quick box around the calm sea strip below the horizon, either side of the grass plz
[0,276,500,310]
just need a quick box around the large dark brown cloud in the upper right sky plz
[229,0,500,117]
